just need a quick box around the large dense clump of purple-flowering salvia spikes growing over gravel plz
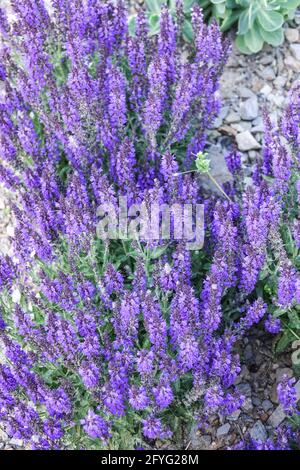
[0,0,300,449]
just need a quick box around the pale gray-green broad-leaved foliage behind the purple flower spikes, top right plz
[140,0,300,54]
